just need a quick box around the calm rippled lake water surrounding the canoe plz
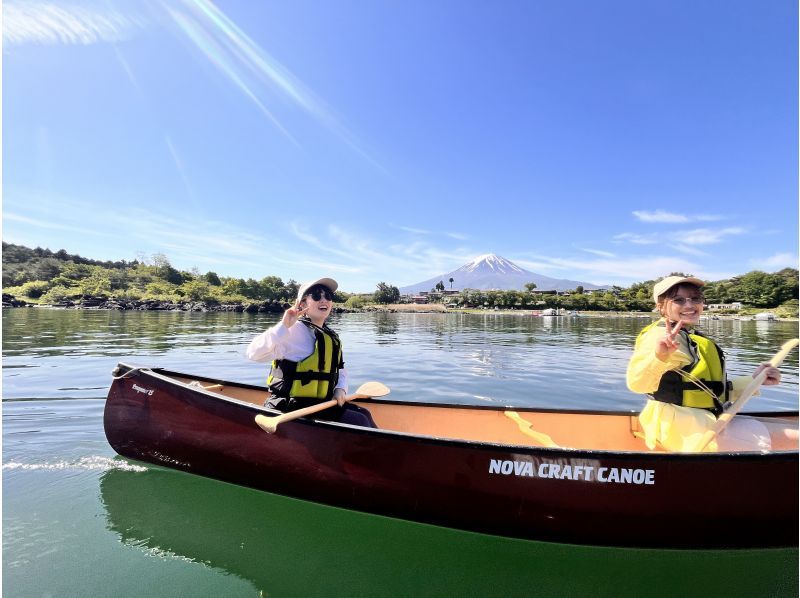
[2,309,798,597]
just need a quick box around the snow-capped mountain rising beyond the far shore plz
[400,253,605,294]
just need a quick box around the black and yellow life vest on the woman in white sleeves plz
[267,318,344,399]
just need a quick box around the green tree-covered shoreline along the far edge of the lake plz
[3,242,798,317]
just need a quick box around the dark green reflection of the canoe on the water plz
[100,468,798,596]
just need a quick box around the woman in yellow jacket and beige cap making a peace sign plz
[627,276,798,451]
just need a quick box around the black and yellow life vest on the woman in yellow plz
[639,319,729,415]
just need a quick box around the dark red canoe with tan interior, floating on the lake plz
[104,364,798,548]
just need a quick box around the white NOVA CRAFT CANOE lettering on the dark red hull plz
[489,458,656,486]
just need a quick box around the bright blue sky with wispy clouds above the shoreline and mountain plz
[3,0,798,292]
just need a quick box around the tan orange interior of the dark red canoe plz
[166,371,798,452]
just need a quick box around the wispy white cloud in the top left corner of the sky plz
[3,0,144,46]
